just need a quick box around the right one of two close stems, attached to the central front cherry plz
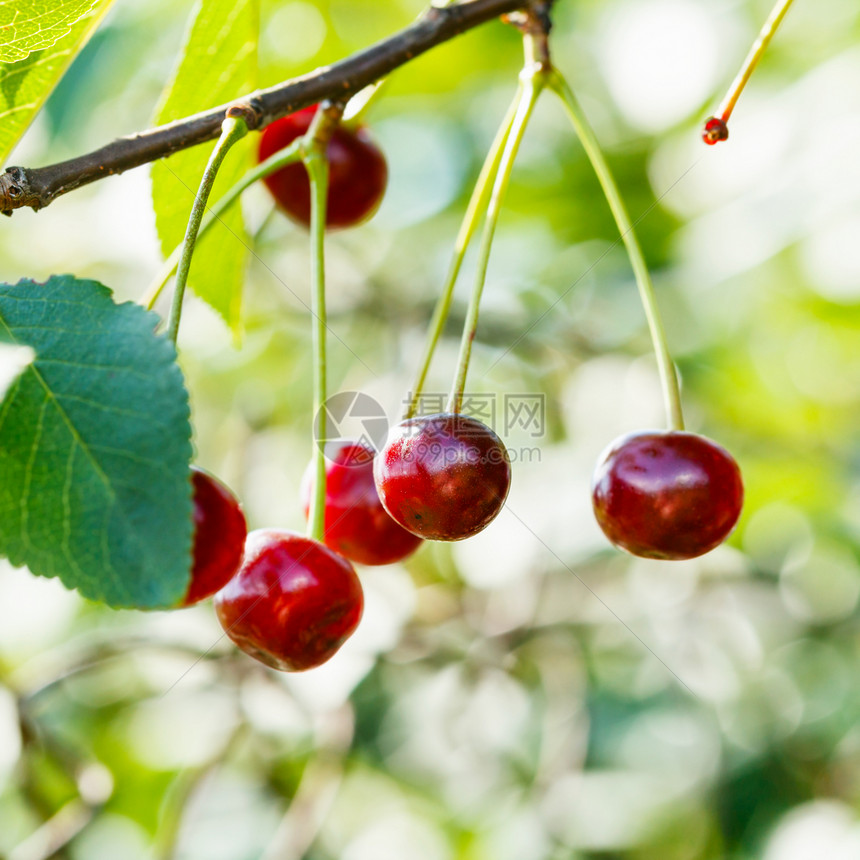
[448,75,545,412]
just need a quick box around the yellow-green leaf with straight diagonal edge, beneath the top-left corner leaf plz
[0,0,113,164]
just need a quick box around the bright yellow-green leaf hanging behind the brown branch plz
[152,0,259,333]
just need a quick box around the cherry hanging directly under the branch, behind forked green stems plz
[259,105,388,228]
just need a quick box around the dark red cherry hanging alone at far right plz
[592,430,744,559]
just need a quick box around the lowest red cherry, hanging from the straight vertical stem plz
[215,529,364,672]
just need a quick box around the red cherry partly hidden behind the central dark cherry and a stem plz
[301,442,421,564]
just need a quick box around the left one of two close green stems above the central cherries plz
[403,85,522,419]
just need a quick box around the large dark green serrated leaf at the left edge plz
[0,275,192,608]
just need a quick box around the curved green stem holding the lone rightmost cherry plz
[549,69,684,430]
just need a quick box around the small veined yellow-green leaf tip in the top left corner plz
[0,0,98,63]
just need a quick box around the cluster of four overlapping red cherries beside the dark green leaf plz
[182,414,511,671]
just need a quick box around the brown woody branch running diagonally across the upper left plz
[0,0,546,215]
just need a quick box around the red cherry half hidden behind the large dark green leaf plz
[180,466,248,606]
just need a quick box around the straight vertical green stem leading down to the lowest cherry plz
[304,142,329,541]
